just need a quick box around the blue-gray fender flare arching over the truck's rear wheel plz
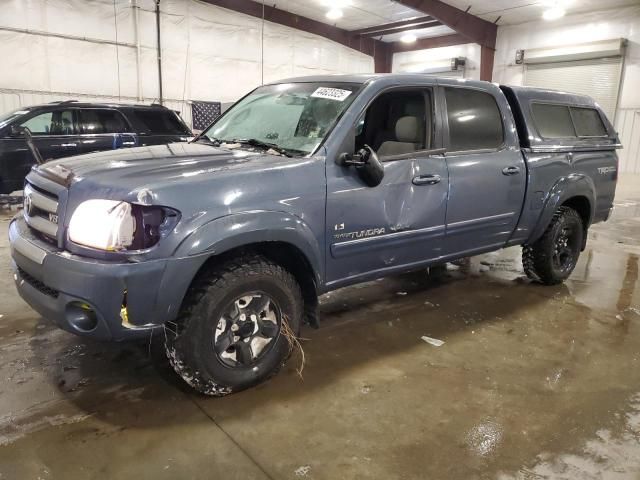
[527,173,597,244]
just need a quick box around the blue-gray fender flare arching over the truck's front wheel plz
[174,210,324,285]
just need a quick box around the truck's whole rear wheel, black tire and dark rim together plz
[522,207,585,285]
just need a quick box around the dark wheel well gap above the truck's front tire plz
[195,242,318,326]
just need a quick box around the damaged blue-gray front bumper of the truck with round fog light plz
[9,217,202,340]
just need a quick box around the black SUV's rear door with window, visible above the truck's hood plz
[78,108,137,153]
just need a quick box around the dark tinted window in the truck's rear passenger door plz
[445,88,503,151]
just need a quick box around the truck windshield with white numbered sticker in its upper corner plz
[202,82,360,156]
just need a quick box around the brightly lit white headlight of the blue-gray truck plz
[69,200,136,250]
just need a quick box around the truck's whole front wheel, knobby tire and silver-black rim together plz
[165,256,304,396]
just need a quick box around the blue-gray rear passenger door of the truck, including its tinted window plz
[440,85,527,255]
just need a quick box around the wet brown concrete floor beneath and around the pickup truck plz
[0,177,640,480]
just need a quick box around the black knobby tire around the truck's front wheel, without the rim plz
[165,255,304,396]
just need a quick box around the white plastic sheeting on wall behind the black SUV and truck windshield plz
[0,0,373,122]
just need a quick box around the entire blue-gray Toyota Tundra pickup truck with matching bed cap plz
[9,74,620,395]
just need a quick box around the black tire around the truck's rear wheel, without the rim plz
[522,207,586,285]
